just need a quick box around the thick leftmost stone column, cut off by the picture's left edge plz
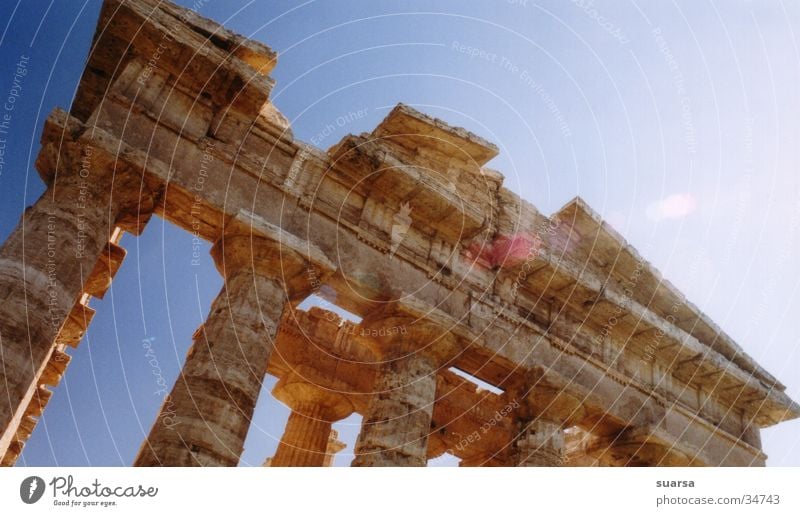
[0,164,150,456]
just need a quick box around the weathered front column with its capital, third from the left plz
[352,310,457,466]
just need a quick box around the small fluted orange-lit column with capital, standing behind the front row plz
[270,374,353,467]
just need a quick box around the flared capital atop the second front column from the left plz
[211,210,336,301]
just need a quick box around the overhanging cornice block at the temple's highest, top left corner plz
[73,0,276,120]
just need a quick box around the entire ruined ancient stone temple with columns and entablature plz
[0,0,800,466]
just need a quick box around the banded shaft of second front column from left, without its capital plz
[135,269,284,466]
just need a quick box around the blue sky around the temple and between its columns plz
[0,0,800,466]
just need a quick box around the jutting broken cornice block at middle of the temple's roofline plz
[328,104,498,247]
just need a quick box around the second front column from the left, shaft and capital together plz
[134,214,333,466]
